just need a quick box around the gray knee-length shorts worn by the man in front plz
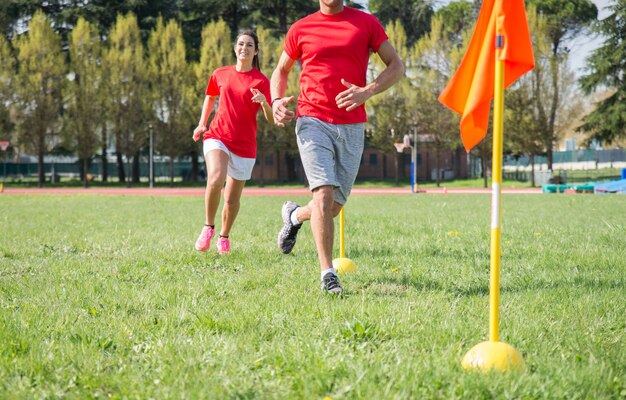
[296,116,365,204]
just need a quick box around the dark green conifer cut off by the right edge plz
[579,0,626,144]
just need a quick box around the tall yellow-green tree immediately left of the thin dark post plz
[105,14,149,186]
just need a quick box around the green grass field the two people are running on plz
[0,195,626,399]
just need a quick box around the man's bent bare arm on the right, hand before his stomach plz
[335,40,404,111]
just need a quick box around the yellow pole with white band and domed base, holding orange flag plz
[461,10,525,372]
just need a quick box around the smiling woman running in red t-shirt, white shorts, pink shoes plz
[193,30,274,254]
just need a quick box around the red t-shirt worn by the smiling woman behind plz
[203,65,270,158]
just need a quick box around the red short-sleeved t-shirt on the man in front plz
[285,7,387,124]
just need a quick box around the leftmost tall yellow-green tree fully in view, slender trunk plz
[16,11,65,187]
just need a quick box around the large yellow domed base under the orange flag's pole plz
[461,342,526,372]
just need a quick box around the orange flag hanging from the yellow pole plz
[439,0,535,152]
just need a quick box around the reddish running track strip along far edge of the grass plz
[0,187,541,196]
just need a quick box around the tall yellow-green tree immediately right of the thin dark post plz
[148,18,193,187]
